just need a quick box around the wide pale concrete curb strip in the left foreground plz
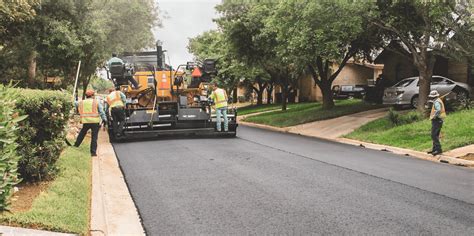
[90,131,145,235]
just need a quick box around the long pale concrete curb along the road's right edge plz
[239,121,474,168]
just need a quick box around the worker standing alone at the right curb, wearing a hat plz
[428,90,446,156]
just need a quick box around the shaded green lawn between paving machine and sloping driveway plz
[244,99,382,127]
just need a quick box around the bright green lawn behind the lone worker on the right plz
[346,110,474,151]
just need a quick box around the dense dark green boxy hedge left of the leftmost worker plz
[15,89,72,182]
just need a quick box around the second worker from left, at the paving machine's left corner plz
[106,87,127,137]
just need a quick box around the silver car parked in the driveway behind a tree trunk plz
[383,75,472,107]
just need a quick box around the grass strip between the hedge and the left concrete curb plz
[0,144,92,235]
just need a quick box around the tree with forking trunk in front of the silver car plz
[372,1,472,112]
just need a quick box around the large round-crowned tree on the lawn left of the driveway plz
[268,1,376,109]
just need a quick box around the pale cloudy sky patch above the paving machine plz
[155,0,220,67]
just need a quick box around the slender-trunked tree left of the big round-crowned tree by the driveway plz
[217,1,297,110]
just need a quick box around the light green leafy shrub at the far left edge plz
[0,85,26,211]
